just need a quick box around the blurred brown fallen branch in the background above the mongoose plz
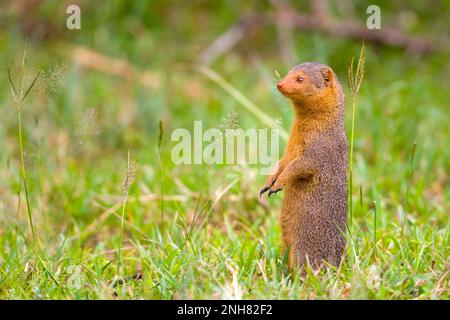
[198,0,439,64]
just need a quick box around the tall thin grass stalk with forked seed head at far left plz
[7,46,40,240]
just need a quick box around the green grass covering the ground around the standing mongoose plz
[0,2,450,299]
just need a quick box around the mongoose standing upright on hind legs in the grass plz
[260,62,347,269]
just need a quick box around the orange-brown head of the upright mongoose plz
[277,62,343,109]
